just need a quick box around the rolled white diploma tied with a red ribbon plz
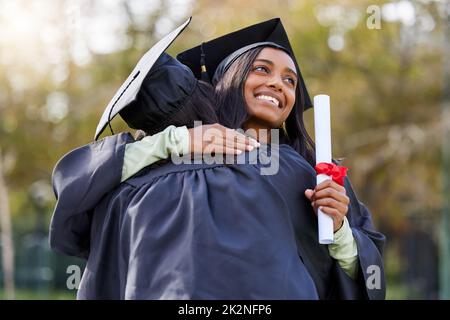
[314,94,334,244]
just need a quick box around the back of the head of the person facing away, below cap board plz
[120,53,217,138]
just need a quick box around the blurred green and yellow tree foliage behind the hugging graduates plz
[0,0,450,299]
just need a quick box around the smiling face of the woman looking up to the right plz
[244,47,298,128]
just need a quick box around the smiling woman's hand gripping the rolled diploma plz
[305,180,350,232]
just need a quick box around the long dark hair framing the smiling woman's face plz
[215,47,315,166]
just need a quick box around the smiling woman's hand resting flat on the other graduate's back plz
[189,123,259,154]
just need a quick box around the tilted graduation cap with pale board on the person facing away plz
[94,18,192,140]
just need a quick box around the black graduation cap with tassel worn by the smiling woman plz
[177,18,312,110]
